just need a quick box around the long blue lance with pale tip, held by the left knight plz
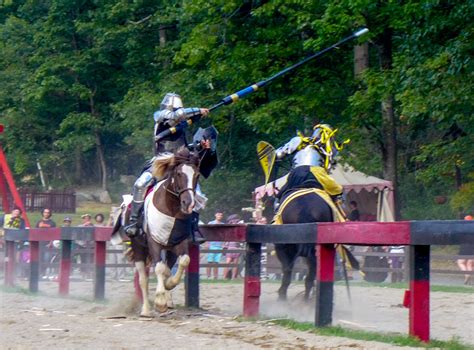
[155,28,369,142]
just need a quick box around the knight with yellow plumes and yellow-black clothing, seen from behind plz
[275,124,348,208]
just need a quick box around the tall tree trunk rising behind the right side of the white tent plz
[380,28,400,220]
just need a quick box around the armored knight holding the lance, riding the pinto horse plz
[124,93,217,241]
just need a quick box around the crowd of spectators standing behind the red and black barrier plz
[0,205,474,285]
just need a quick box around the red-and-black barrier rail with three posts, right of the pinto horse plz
[201,221,474,342]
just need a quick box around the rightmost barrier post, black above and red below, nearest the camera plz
[409,245,430,342]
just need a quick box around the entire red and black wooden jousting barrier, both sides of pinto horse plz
[5,221,474,341]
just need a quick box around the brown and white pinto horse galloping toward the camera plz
[131,148,199,316]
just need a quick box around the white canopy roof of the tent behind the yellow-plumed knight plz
[255,164,393,198]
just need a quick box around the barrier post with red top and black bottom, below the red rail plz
[314,244,336,327]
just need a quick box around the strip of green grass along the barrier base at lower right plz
[268,319,473,350]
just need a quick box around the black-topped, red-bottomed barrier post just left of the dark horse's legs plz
[243,243,262,317]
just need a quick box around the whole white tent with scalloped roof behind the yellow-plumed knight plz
[255,164,395,221]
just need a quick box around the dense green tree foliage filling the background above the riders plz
[0,0,474,219]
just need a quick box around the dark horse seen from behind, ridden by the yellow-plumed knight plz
[275,189,333,300]
